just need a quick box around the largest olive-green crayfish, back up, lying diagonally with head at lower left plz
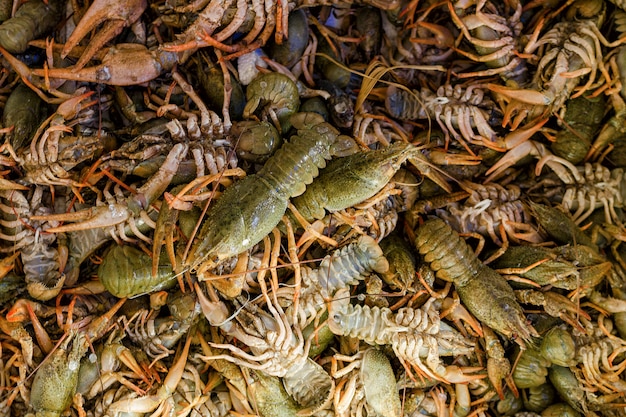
[186,113,346,276]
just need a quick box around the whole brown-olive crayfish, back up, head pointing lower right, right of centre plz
[415,218,539,348]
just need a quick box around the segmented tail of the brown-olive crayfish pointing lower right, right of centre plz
[415,218,484,287]
